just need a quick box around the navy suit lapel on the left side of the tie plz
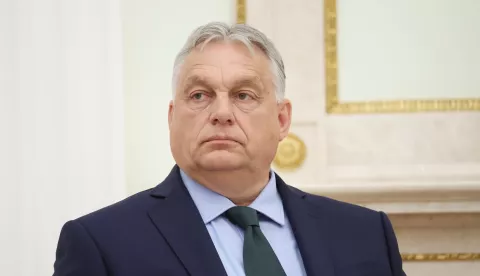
[149,166,227,276]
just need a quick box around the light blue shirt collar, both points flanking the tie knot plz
[180,170,285,226]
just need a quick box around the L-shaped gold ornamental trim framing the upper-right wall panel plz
[324,0,480,114]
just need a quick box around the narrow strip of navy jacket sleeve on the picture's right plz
[380,212,406,276]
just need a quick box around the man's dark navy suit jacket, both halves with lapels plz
[54,166,405,276]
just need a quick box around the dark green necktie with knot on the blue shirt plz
[226,206,286,276]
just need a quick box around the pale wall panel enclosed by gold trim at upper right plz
[337,0,480,102]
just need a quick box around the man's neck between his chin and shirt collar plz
[184,166,270,206]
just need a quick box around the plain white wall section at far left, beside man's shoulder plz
[0,0,126,276]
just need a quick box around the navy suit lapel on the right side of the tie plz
[276,176,335,276]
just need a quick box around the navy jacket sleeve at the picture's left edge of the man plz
[53,221,107,276]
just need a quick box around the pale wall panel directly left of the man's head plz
[122,0,236,193]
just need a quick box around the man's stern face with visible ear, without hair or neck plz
[168,42,291,171]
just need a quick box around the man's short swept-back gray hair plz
[172,22,285,101]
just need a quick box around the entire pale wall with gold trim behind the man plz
[0,0,480,276]
